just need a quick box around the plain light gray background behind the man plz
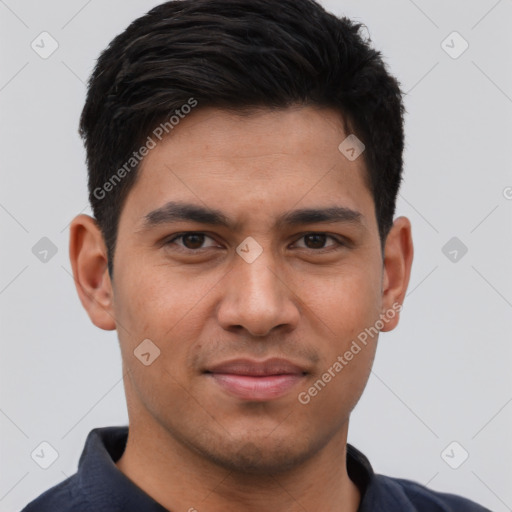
[0,0,512,512]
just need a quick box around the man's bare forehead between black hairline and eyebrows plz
[120,107,373,229]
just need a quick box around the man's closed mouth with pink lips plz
[205,358,308,402]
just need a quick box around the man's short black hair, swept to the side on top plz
[80,0,404,275]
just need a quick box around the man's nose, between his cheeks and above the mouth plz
[217,251,300,337]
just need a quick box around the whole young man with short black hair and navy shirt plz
[21,0,492,512]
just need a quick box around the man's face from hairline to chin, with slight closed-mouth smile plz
[71,107,410,473]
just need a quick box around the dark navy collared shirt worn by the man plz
[22,427,490,512]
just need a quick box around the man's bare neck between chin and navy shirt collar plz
[116,418,361,512]
